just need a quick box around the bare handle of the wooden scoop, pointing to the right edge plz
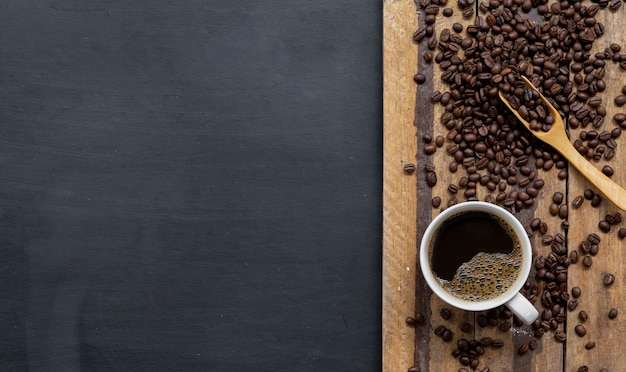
[552,141,626,211]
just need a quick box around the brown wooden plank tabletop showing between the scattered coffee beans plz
[383,0,626,371]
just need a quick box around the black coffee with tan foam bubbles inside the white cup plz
[429,212,522,301]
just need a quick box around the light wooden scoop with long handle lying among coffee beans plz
[498,76,626,210]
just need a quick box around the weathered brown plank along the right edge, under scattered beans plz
[565,6,626,371]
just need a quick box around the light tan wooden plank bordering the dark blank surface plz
[383,1,417,371]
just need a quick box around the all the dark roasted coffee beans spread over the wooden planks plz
[404,0,626,371]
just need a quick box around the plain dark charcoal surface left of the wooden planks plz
[0,0,382,371]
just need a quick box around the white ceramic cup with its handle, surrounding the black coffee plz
[419,201,539,324]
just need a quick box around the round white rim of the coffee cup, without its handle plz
[419,201,532,311]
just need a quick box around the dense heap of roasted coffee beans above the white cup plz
[413,0,626,212]
